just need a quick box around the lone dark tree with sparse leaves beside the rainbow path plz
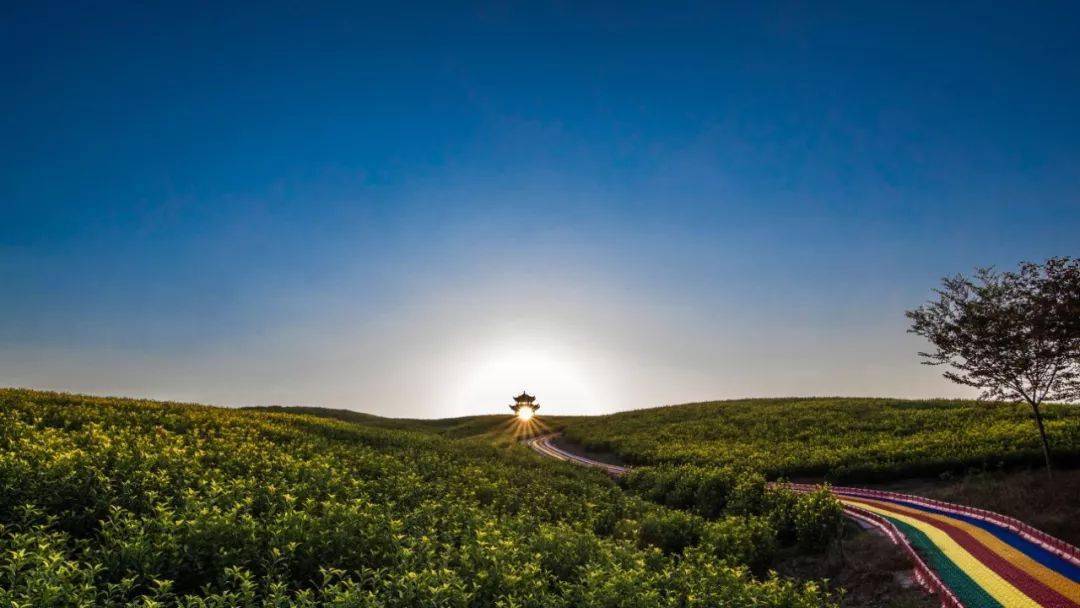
[907,257,1080,474]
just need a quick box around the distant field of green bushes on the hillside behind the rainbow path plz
[564,398,1080,482]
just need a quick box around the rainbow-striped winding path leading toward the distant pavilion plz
[525,433,1080,608]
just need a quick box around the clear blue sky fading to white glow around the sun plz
[0,2,1080,417]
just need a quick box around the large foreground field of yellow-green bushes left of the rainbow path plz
[0,390,839,608]
